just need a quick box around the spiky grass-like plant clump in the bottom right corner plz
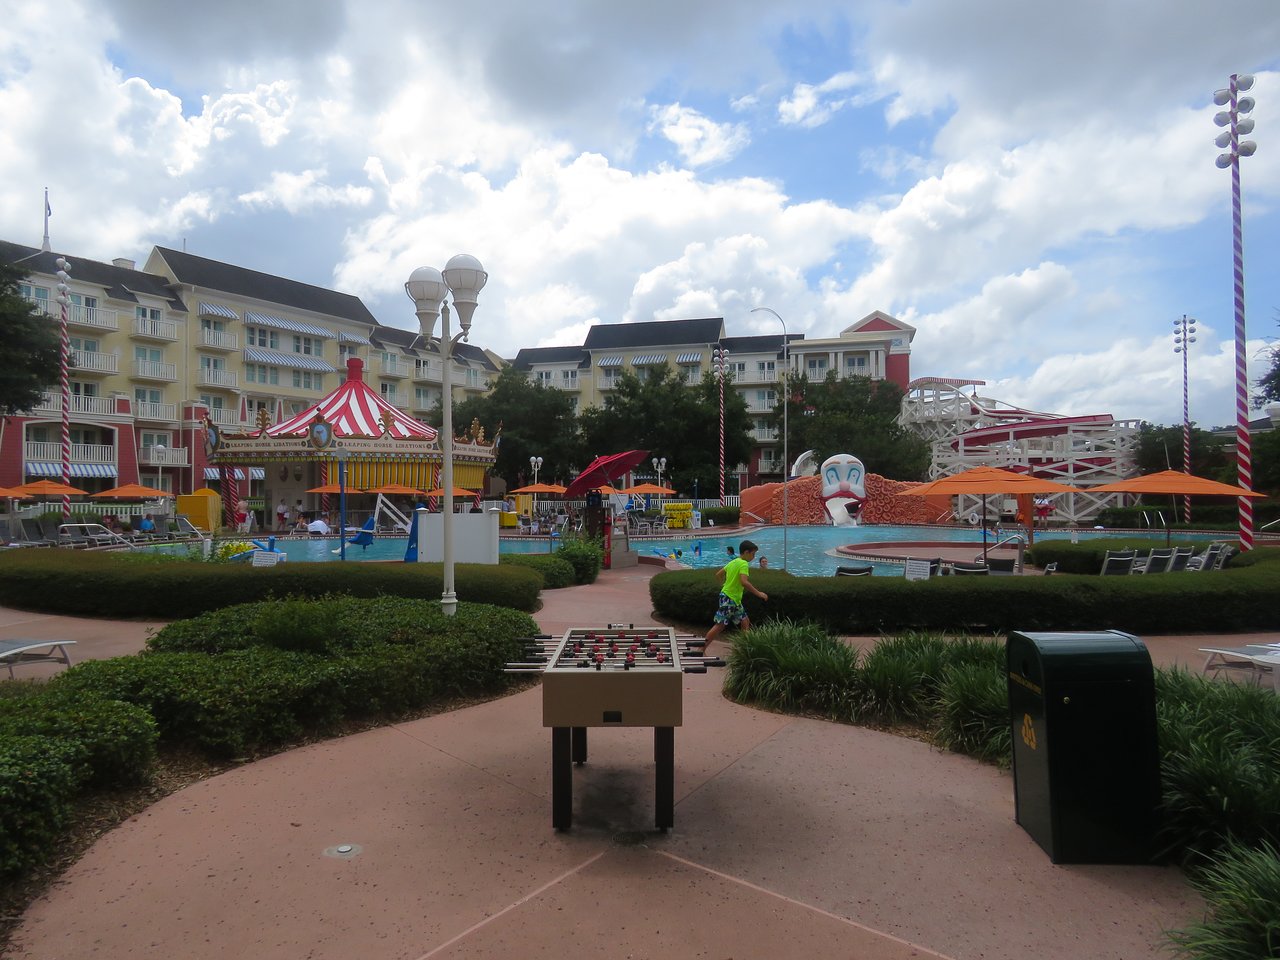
[1169,844,1280,960]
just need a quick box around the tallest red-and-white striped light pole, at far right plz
[1213,73,1258,550]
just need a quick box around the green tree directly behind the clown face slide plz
[773,370,929,480]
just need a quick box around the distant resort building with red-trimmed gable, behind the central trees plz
[511,311,915,489]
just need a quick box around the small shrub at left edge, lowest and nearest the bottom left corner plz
[0,736,78,876]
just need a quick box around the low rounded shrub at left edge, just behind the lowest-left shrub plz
[0,685,156,787]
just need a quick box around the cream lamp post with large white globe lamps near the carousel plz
[404,253,489,617]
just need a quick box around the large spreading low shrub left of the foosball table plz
[49,596,538,756]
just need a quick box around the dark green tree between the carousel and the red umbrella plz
[448,366,582,488]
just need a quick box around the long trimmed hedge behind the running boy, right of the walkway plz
[649,550,1280,635]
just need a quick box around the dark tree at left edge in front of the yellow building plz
[0,264,59,415]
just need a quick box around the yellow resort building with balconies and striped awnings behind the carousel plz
[0,242,498,507]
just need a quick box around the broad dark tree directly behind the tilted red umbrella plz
[580,365,755,497]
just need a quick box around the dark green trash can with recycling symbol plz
[1005,630,1160,864]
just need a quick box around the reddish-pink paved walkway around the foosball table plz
[10,567,1264,960]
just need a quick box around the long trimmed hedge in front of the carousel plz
[0,550,543,620]
